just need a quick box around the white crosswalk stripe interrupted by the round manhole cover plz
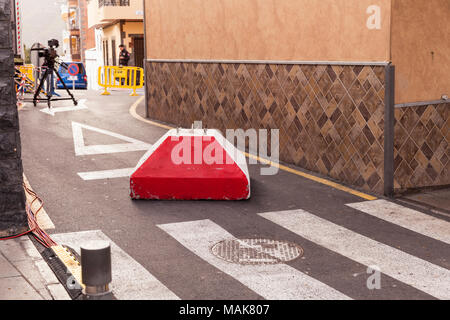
[158,220,350,300]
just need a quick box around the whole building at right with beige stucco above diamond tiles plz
[145,0,450,194]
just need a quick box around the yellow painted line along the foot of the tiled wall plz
[129,96,378,201]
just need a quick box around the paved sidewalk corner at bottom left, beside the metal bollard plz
[0,236,70,300]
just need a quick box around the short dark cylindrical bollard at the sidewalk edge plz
[81,241,113,300]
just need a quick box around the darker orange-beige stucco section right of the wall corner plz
[391,0,450,103]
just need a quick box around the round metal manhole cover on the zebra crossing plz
[211,239,303,264]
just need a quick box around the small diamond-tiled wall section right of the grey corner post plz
[394,103,450,191]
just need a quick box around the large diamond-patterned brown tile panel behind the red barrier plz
[146,61,385,193]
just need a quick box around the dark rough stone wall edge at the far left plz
[0,0,28,237]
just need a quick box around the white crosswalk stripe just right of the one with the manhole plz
[259,210,450,299]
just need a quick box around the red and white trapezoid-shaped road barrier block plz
[130,129,250,200]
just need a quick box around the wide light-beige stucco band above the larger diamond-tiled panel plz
[146,0,390,61]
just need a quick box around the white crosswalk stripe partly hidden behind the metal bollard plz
[52,230,179,300]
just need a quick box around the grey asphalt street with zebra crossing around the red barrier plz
[19,91,450,299]
